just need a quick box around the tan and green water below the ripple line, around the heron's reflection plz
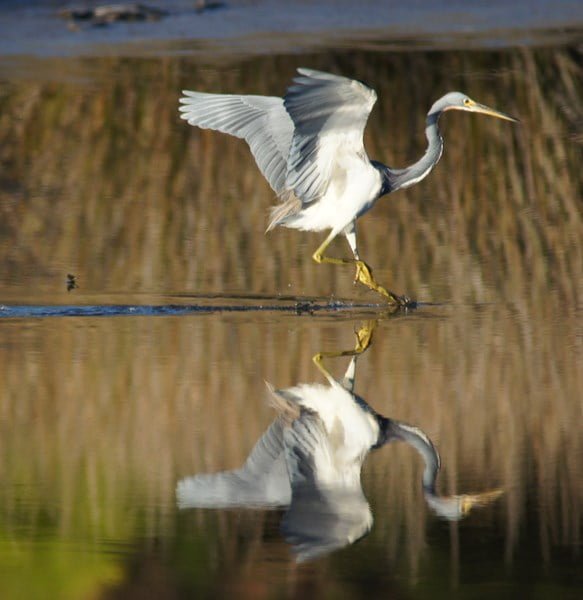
[0,306,582,598]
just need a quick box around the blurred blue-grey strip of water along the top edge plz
[0,0,583,57]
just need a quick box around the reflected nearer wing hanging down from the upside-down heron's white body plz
[281,412,373,562]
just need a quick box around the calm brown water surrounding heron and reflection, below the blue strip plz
[0,3,583,600]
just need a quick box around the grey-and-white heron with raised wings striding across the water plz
[180,69,516,306]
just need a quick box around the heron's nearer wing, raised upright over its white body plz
[284,69,377,203]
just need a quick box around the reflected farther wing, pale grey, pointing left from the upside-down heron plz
[176,420,291,508]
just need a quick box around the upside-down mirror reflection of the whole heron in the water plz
[177,323,502,561]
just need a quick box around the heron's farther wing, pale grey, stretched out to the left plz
[179,90,294,194]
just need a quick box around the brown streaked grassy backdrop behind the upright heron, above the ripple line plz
[0,49,583,306]
